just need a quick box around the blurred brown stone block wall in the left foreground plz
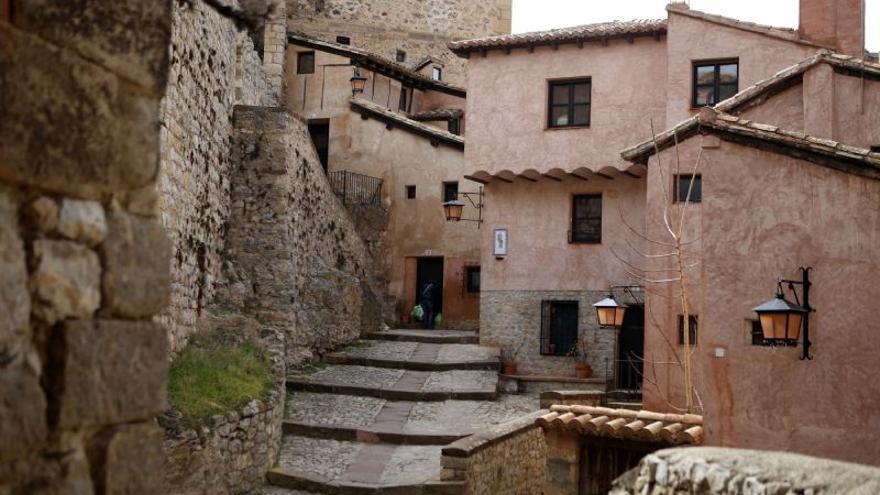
[0,0,172,494]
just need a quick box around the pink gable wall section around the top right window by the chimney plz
[668,11,819,127]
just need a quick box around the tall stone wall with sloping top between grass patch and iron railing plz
[223,107,381,364]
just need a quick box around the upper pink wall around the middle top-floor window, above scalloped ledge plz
[466,38,666,176]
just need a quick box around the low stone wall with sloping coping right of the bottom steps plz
[441,410,547,495]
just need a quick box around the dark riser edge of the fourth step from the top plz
[281,420,472,445]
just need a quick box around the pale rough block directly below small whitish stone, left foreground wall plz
[30,239,101,324]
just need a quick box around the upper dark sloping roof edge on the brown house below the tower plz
[287,33,467,98]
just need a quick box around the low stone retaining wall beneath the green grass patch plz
[161,330,286,495]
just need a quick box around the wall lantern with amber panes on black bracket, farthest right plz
[753,267,813,359]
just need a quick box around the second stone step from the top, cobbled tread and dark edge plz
[324,340,501,371]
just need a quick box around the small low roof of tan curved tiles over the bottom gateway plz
[535,405,703,445]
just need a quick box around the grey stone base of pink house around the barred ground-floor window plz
[480,290,625,378]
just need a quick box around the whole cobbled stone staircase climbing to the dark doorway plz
[264,330,538,495]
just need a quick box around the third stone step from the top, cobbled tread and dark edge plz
[287,364,498,401]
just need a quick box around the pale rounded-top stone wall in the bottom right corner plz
[611,447,880,495]
